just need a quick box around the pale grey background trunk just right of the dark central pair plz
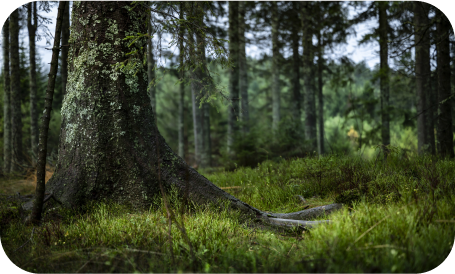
[271,0,281,131]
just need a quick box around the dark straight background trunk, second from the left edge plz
[9,9,24,171]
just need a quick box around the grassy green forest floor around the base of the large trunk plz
[0,151,455,273]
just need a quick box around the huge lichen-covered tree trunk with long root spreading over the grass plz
[24,0,341,228]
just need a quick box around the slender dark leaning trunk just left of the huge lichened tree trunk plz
[27,0,69,224]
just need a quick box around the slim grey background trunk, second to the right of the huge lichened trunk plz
[178,0,185,159]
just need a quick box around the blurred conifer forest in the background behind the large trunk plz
[0,0,455,176]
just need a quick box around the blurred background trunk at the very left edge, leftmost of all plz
[2,18,12,174]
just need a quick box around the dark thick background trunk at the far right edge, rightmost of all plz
[436,9,454,158]
